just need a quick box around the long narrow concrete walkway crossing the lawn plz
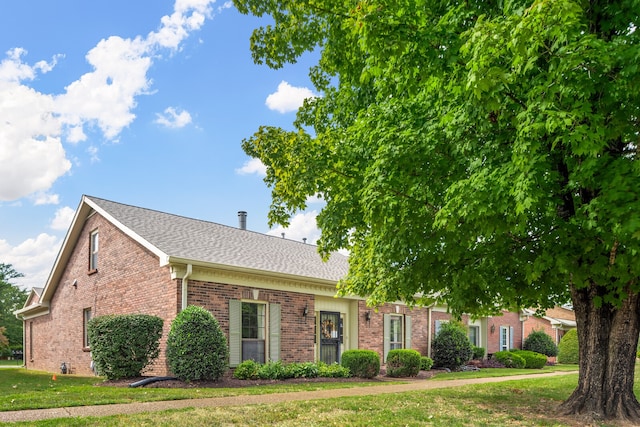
[0,371,578,422]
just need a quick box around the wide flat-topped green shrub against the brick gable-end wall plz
[87,314,163,379]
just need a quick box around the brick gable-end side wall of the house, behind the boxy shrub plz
[25,214,177,375]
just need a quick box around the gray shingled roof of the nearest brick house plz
[85,196,348,282]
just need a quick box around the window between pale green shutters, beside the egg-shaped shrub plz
[242,302,267,363]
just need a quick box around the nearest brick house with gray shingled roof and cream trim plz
[16,196,432,375]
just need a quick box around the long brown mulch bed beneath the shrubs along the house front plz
[96,368,444,388]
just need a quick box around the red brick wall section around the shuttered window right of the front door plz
[358,301,429,360]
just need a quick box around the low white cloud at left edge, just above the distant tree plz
[0,233,62,289]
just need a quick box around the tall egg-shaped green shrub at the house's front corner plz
[167,305,229,381]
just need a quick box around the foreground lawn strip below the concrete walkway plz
[0,372,596,427]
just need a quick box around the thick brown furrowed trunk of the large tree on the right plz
[560,283,640,424]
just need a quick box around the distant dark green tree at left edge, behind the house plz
[0,263,28,352]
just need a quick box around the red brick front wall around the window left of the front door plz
[188,280,315,363]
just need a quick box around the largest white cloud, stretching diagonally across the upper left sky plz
[0,0,220,201]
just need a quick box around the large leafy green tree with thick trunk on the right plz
[235,0,640,422]
